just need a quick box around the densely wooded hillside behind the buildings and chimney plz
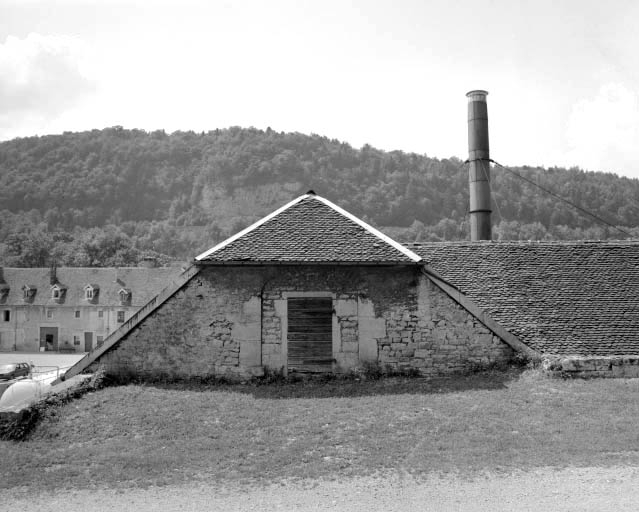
[0,127,639,266]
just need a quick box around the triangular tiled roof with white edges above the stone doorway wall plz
[196,193,420,264]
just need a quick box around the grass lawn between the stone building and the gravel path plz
[0,371,639,490]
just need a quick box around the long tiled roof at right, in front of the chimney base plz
[409,241,639,355]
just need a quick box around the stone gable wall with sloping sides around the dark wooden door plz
[99,265,513,378]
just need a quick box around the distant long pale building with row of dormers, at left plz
[0,262,180,352]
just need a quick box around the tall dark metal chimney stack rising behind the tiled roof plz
[466,90,492,242]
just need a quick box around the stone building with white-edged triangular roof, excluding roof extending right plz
[66,193,525,377]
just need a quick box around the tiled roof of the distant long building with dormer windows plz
[0,267,180,308]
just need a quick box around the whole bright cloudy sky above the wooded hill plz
[0,0,639,178]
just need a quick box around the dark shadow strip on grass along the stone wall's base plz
[129,368,523,400]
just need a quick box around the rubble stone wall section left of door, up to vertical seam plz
[98,271,262,378]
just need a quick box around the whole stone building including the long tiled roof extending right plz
[62,192,639,378]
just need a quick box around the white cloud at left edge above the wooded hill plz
[0,33,94,138]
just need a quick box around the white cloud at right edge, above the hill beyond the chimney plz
[564,83,639,177]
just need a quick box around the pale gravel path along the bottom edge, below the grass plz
[5,467,639,512]
